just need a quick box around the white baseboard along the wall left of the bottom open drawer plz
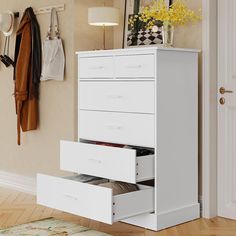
[0,171,36,195]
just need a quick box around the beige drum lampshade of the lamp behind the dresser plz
[88,7,119,26]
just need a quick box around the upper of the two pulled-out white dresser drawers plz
[60,141,154,183]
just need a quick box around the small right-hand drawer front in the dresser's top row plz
[115,54,155,78]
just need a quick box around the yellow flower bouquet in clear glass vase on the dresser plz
[129,0,201,46]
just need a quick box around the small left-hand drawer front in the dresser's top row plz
[79,57,114,79]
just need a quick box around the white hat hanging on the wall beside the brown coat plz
[0,11,15,36]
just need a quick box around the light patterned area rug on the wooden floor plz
[0,218,111,236]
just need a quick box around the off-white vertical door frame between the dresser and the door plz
[200,0,218,218]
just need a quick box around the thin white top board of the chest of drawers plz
[76,46,200,56]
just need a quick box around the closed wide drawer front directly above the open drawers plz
[79,110,155,147]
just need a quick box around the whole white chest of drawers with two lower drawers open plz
[37,47,199,230]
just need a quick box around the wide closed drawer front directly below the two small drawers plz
[79,81,155,113]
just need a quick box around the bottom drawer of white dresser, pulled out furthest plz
[37,174,154,224]
